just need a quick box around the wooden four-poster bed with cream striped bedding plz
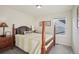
[13,21,55,54]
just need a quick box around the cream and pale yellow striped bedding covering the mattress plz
[15,33,52,53]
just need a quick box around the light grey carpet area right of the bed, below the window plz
[49,44,74,54]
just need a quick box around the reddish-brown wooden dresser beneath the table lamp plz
[0,35,13,52]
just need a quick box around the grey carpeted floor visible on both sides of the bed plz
[1,44,73,54]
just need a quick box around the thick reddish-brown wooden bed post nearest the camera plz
[41,21,46,54]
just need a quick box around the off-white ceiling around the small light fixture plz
[9,5,73,16]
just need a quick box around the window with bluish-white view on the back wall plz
[54,18,66,34]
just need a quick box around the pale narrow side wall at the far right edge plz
[72,6,79,53]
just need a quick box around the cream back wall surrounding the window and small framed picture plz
[35,10,72,46]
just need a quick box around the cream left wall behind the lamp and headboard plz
[0,6,34,34]
